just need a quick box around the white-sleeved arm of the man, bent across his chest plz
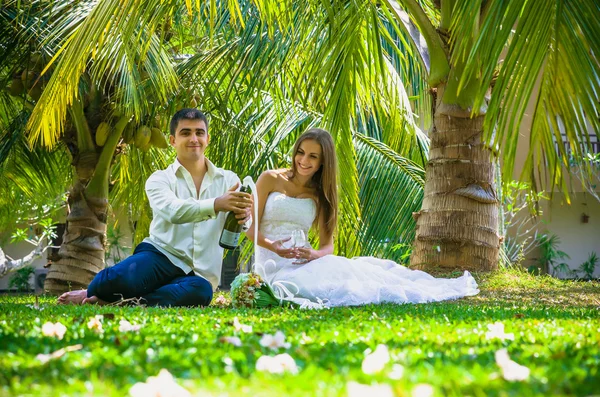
[146,174,216,224]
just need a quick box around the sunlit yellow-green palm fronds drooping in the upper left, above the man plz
[29,0,206,146]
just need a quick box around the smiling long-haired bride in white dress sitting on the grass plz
[248,129,479,307]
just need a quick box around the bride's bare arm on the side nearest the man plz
[246,170,294,258]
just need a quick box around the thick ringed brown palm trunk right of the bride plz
[411,86,500,270]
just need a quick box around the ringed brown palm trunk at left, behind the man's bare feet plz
[44,182,108,294]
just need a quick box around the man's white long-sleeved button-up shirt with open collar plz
[144,159,240,289]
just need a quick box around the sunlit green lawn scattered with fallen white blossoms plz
[0,270,600,396]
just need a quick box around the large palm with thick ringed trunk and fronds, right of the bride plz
[385,0,600,269]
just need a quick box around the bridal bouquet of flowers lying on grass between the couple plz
[231,272,282,307]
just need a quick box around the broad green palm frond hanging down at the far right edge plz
[486,0,600,193]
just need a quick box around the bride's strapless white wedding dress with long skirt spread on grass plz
[255,192,479,307]
